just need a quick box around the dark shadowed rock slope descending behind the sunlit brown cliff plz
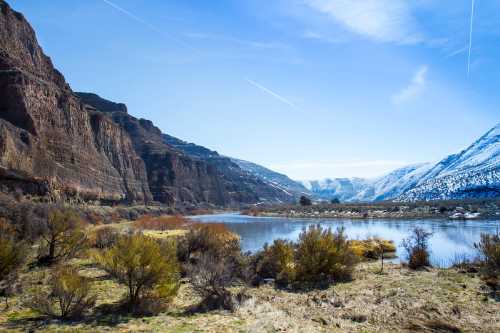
[77,93,293,206]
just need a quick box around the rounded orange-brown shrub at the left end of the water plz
[179,223,240,262]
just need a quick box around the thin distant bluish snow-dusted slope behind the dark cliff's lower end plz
[231,157,311,198]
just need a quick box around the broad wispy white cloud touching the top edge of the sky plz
[304,0,423,44]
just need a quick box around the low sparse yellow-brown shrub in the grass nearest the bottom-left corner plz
[29,265,96,319]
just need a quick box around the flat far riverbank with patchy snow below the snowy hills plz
[246,200,500,220]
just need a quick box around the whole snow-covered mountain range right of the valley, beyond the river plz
[302,124,500,201]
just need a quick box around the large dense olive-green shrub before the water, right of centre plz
[296,225,357,285]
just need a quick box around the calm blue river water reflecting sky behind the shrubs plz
[188,214,500,266]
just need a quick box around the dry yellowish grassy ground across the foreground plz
[0,259,500,333]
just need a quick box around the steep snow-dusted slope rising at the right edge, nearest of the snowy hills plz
[398,124,500,201]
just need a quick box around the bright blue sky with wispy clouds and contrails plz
[9,0,500,179]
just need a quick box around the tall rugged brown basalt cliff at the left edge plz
[0,0,152,202]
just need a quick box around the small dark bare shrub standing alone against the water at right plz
[402,227,432,269]
